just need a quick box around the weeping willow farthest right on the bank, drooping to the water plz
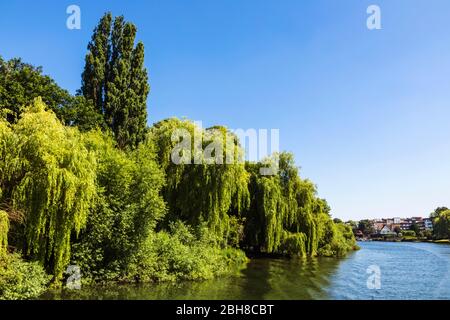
[245,153,351,256]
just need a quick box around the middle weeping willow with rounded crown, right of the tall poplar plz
[150,118,249,244]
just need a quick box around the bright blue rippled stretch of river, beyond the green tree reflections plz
[329,242,450,299]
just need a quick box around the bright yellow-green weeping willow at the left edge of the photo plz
[0,98,96,279]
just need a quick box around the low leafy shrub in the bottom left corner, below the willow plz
[0,254,50,300]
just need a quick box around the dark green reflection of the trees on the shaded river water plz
[42,259,339,300]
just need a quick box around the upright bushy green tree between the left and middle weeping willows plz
[73,131,165,280]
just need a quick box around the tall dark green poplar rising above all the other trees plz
[81,13,150,149]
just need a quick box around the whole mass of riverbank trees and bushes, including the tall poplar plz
[0,13,356,299]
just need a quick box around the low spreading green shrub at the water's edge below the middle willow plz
[129,223,247,282]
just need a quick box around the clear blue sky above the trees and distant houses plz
[0,0,450,219]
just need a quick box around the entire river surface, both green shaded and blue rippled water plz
[43,242,450,300]
